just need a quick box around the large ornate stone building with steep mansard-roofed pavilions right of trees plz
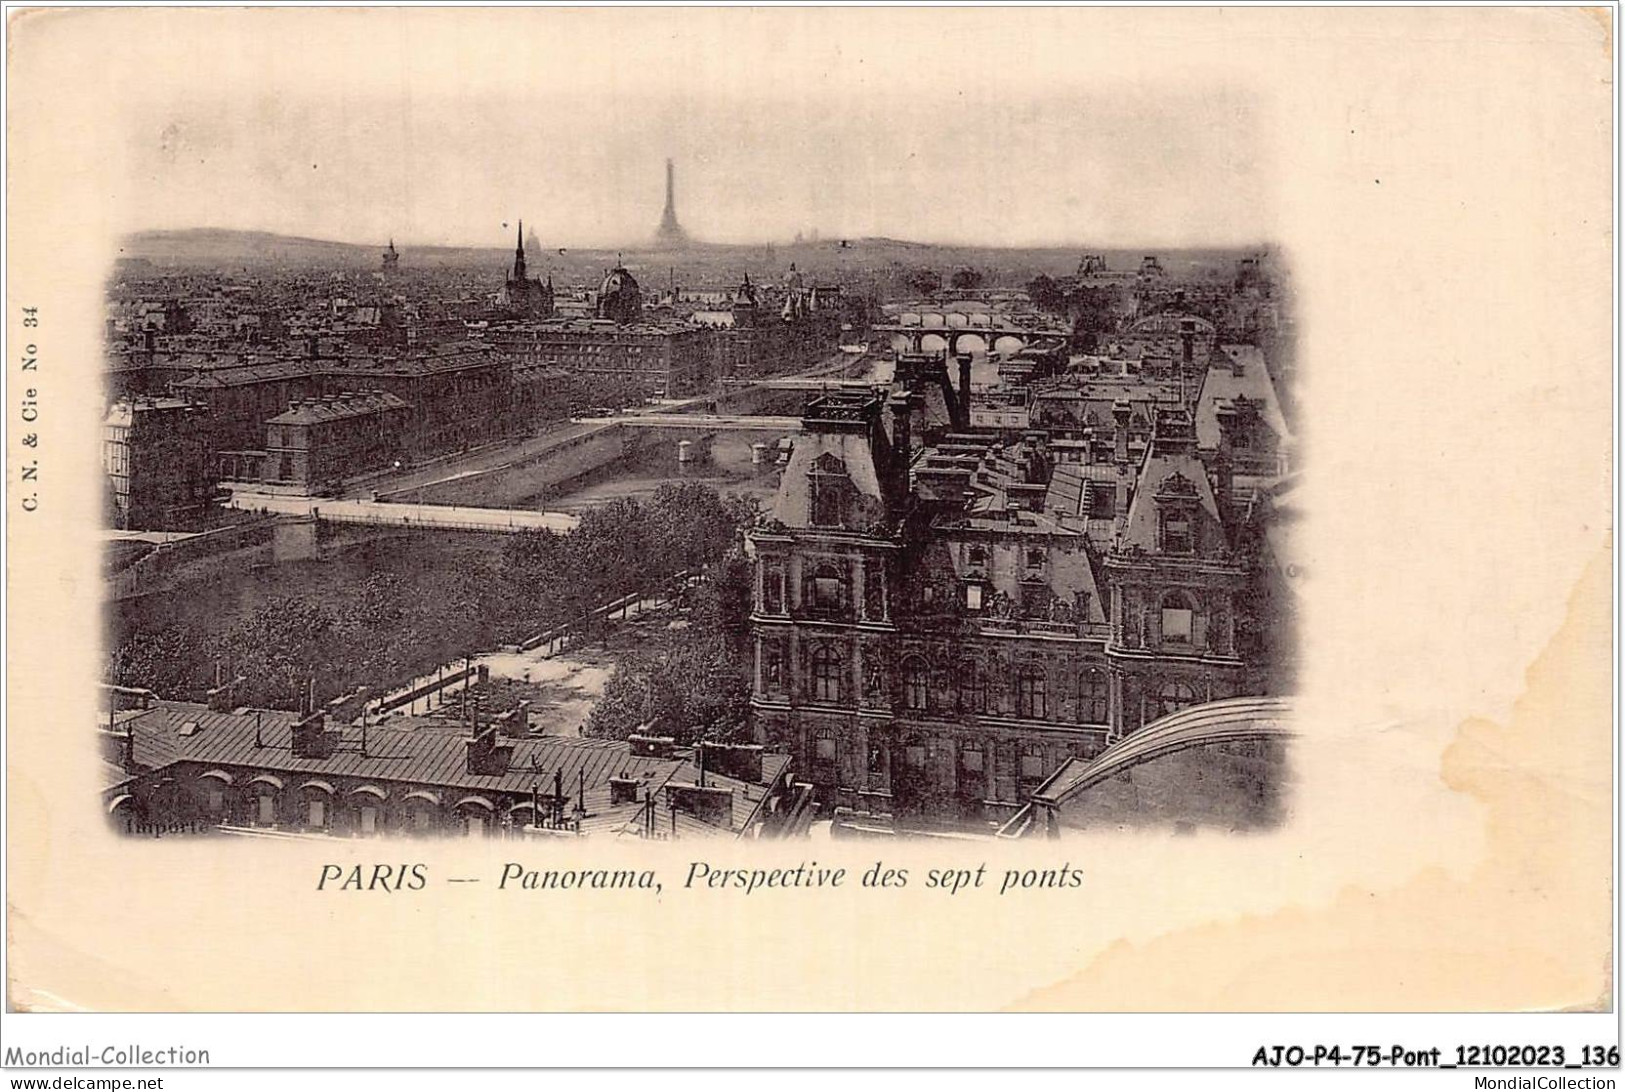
[748,385,1280,829]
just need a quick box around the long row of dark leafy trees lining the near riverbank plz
[106,483,756,709]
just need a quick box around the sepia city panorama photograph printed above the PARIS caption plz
[98,95,1303,842]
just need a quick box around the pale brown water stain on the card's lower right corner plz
[1011,536,1614,1012]
